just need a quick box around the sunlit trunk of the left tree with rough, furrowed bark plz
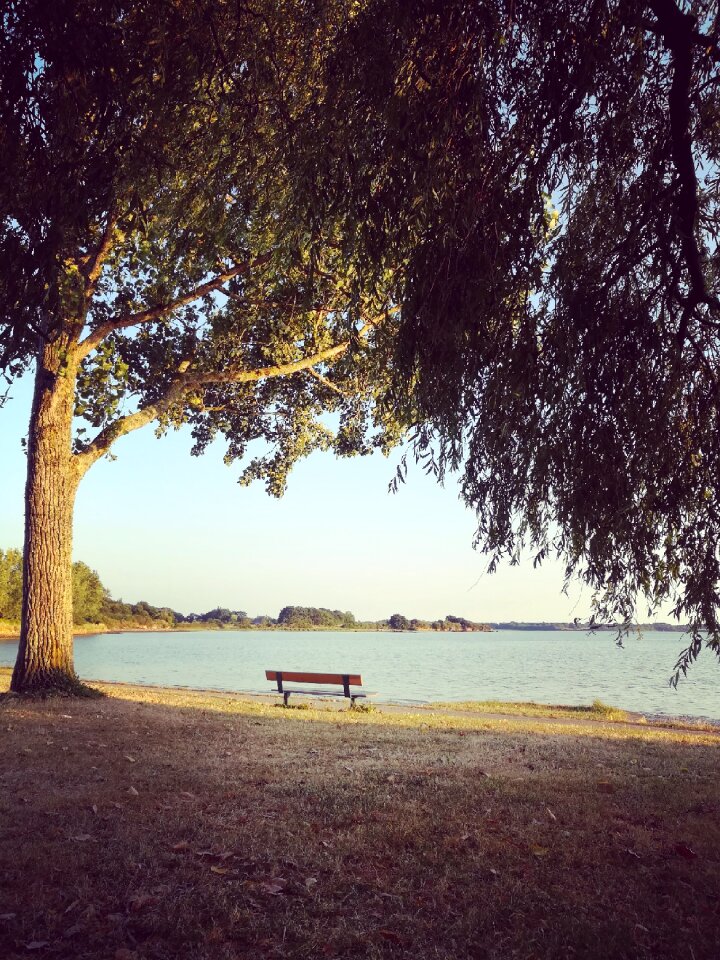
[11,334,79,692]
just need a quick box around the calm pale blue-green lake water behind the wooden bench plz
[0,630,720,720]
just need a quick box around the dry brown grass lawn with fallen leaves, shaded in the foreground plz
[0,672,720,960]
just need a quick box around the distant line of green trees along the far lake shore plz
[0,550,490,632]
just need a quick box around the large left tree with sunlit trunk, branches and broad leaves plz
[0,0,397,691]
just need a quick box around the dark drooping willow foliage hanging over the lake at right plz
[288,0,720,677]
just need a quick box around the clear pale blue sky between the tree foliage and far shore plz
[0,368,589,621]
